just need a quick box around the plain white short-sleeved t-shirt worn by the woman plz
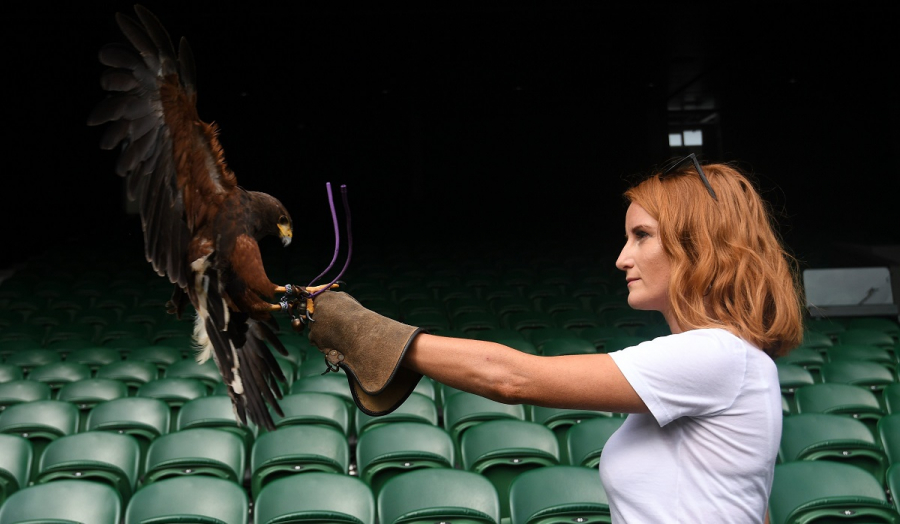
[600,329,782,524]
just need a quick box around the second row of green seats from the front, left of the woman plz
[0,406,624,516]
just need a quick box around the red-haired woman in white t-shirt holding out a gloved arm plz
[310,155,802,523]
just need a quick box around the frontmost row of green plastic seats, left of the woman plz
[0,466,611,524]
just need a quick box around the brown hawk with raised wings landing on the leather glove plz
[88,5,330,429]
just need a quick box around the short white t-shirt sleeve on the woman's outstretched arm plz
[610,329,750,426]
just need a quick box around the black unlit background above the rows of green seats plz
[0,1,900,274]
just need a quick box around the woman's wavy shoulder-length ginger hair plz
[625,164,803,358]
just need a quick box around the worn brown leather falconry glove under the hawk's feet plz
[309,291,422,416]
